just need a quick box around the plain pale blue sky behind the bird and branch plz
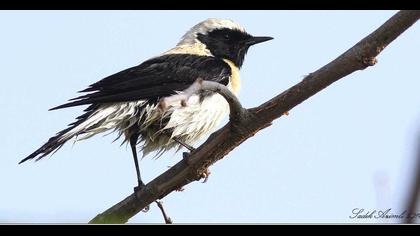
[0,11,420,223]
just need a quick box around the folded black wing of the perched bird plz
[50,54,231,110]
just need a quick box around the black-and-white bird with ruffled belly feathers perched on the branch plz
[19,18,273,191]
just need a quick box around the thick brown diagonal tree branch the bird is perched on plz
[89,11,420,223]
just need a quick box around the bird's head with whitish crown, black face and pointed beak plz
[178,18,273,67]
